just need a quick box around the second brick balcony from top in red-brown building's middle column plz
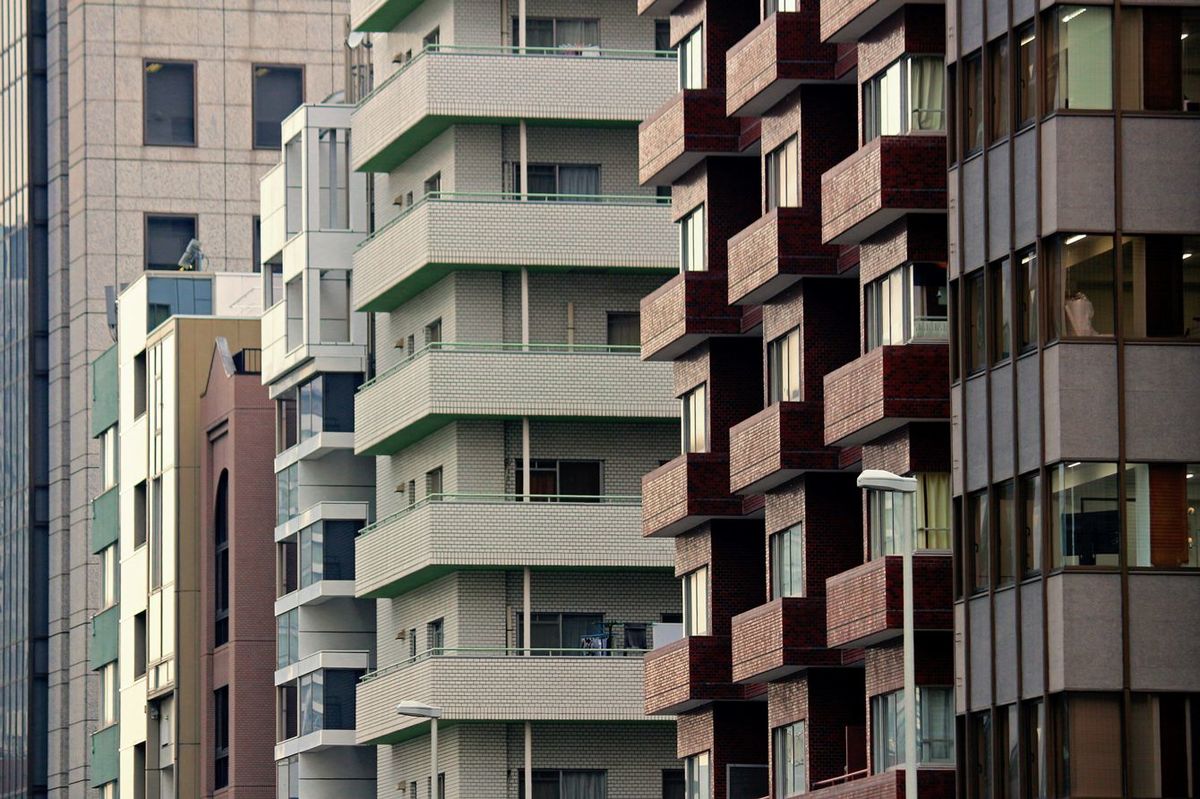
[728,208,841,305]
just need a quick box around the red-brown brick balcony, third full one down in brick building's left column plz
[642,452,742,537]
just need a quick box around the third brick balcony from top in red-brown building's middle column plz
[730,402,840,494]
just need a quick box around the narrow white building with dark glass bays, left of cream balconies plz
[260,104,376,799]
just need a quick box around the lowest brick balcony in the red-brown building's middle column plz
[732,596,842,683]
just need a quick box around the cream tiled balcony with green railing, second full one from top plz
[352,192,679,312]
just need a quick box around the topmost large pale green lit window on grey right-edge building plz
[1044,6,1112,114]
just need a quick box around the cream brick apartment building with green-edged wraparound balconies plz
[350,0,683,799]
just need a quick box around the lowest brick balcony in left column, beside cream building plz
[646,636,744,716]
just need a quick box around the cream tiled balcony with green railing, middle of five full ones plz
[354,342,679,455]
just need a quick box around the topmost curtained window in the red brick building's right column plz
[863,55,946,144]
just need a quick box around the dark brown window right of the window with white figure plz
[1121,235,1200,340]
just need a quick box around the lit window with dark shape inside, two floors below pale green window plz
[1050,461,1121,569]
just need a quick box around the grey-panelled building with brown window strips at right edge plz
[946,2,1200,797]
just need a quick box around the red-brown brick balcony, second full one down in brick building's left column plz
[642,272,743,361]
